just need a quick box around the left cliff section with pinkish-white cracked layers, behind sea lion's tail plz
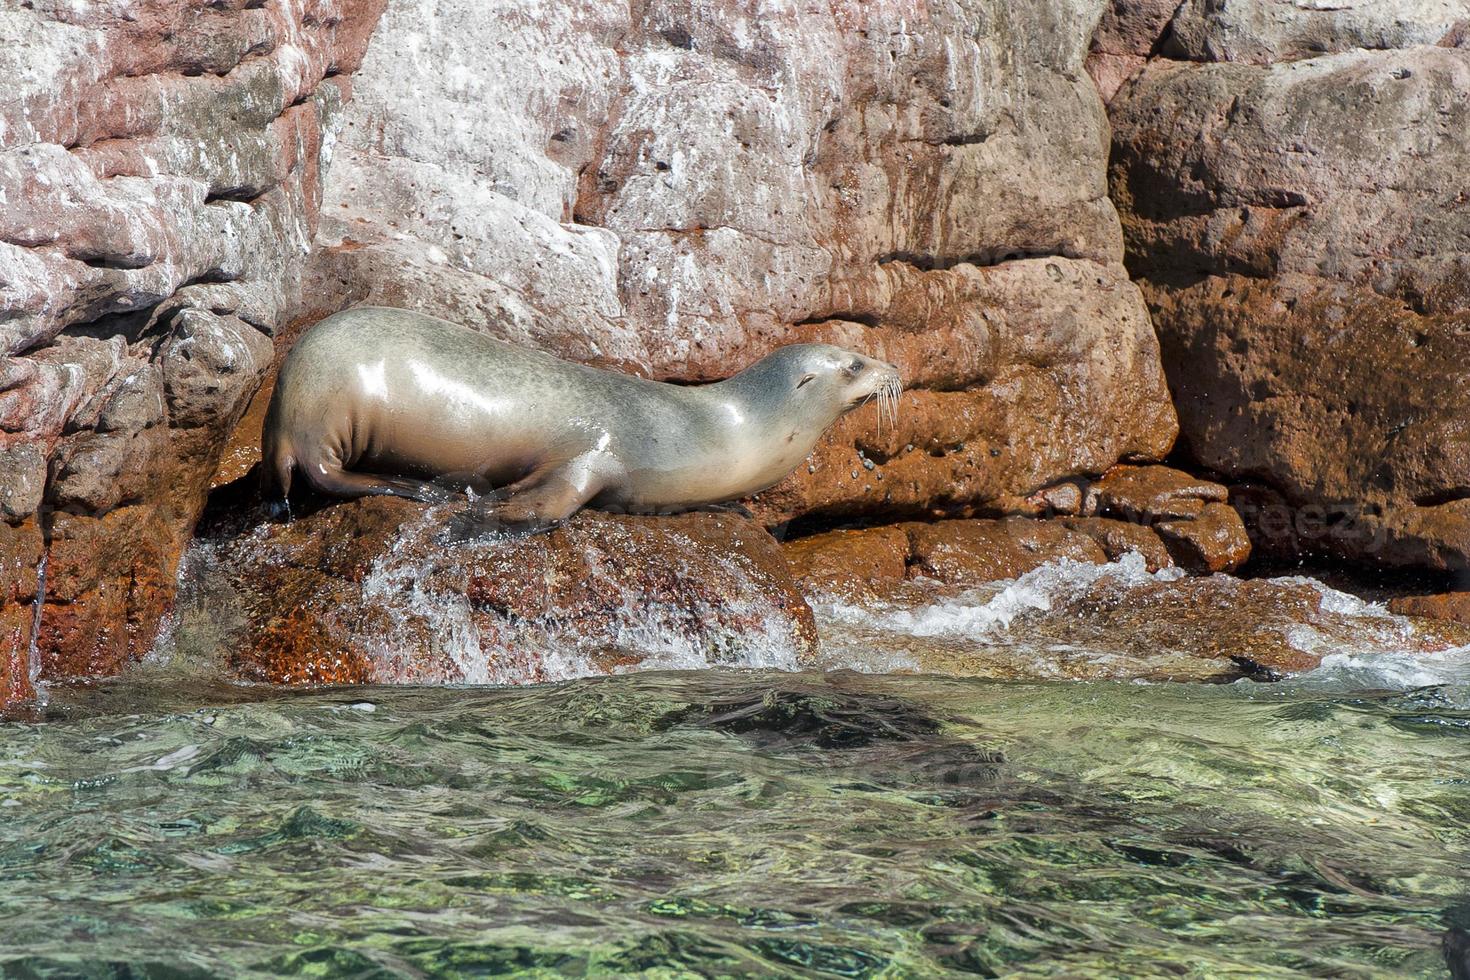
[0,0,381,699]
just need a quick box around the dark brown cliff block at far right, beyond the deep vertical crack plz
[1094,0,1470,570]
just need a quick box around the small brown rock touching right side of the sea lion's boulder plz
[781,526,908,599]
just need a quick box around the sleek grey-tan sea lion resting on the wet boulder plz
[262,307,901,527]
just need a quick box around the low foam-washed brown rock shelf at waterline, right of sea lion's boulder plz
[816,554,1470,682]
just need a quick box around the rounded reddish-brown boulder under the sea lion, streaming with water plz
[175,498,816,683]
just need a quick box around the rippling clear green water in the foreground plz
[0,671,1470,977]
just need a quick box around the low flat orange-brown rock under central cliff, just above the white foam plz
[903,517,1107,585]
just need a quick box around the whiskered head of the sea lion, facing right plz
[756,344,903,429]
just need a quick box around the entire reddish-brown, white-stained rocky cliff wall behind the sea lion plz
[17,0,1470,699]
